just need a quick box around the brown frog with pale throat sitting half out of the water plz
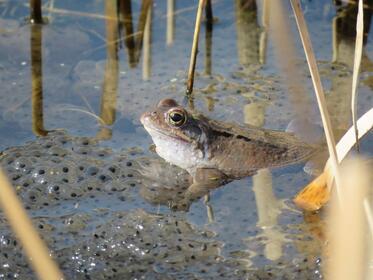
[140,98,316,206]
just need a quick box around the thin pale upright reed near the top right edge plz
[351,0,364,150]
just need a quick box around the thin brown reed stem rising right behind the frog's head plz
[186,0,206,95]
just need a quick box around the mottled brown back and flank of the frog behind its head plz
[205,116,314,179]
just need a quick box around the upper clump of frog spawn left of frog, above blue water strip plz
[1,132,137,209]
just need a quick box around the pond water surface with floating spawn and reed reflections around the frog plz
[0,0,373,279]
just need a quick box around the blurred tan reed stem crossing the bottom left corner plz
[0,170,63,280]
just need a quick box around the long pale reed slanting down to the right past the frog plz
[290,0,341,199]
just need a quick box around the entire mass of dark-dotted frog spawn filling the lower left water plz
[0,131,318,279]
